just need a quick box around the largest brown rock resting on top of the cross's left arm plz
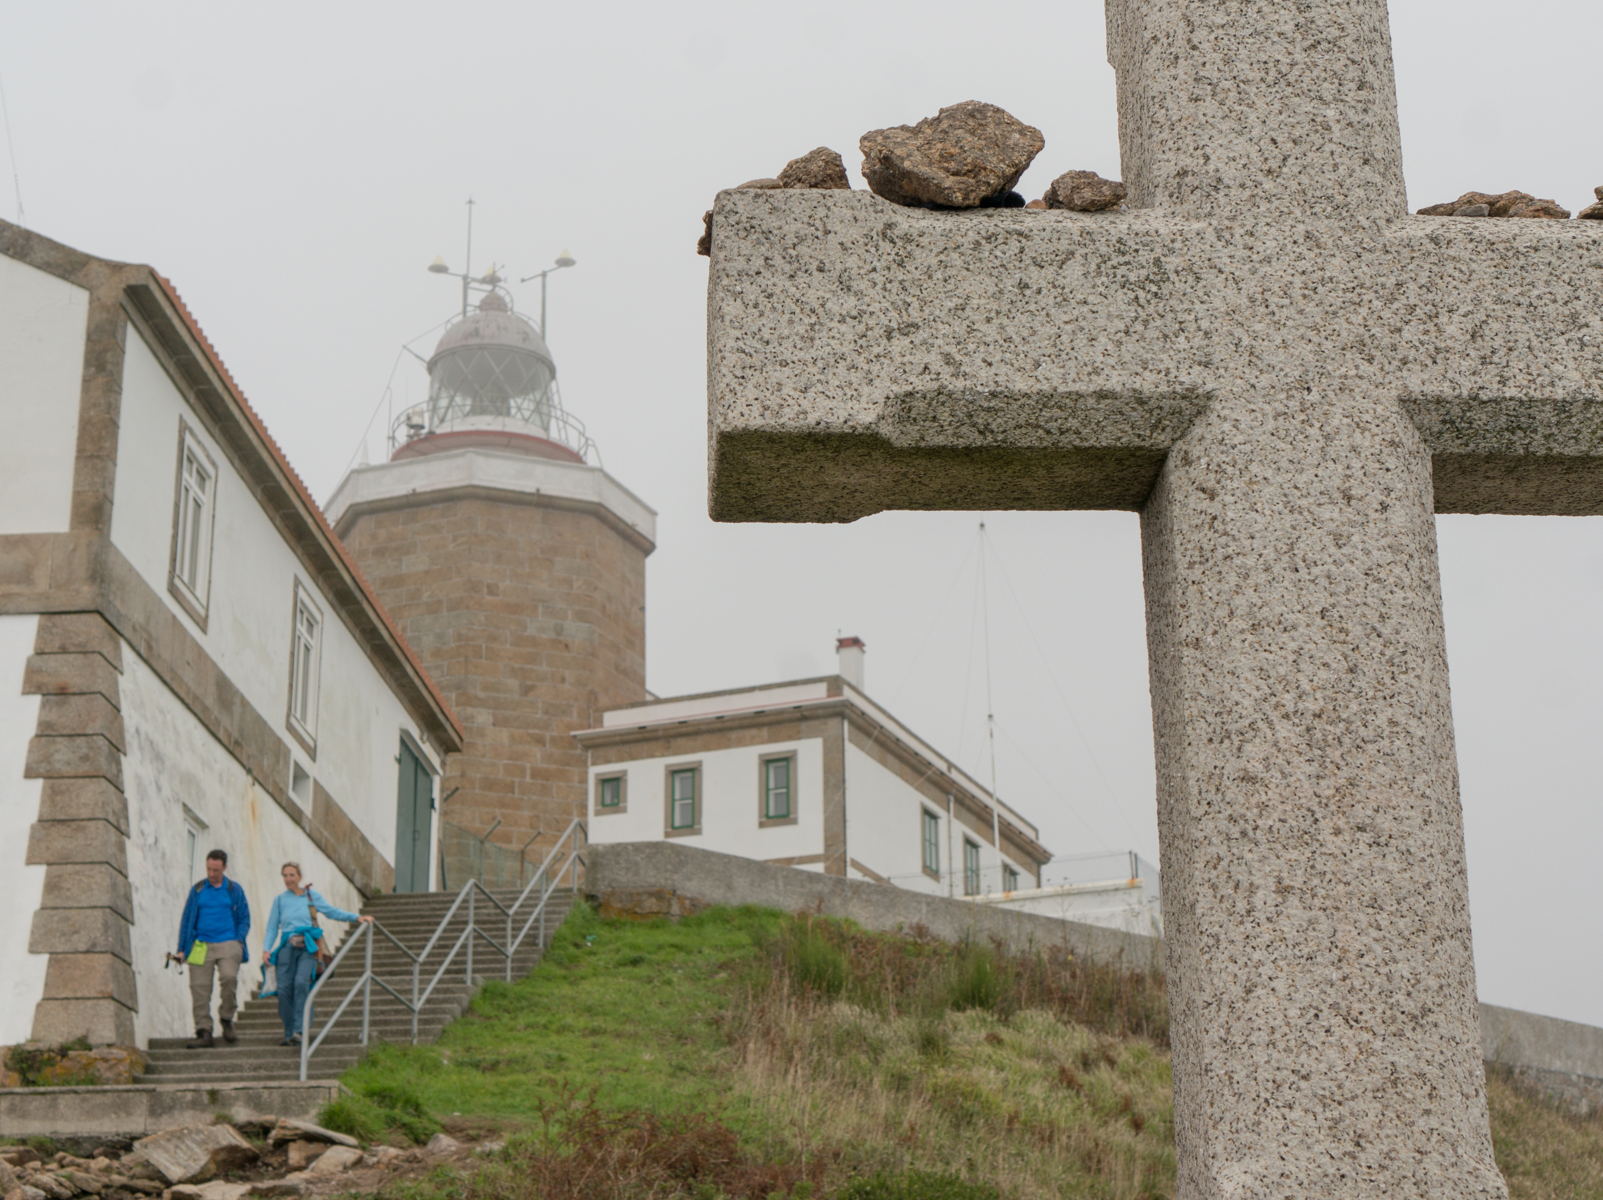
[858,99,1047,208]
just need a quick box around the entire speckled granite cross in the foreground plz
[707,0,1603,1200]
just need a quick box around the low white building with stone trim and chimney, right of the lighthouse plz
[575,638,1052,896]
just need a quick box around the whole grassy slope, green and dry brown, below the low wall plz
[324,905,1603,1200]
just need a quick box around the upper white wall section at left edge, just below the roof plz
[0,255,90,534]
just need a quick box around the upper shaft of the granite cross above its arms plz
[1106,0,1406,216]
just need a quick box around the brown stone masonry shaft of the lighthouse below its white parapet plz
[340,493,649,862]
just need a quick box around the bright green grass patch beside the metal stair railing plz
[343,904,782,1123]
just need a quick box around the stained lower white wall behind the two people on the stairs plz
[121,646,362,1045]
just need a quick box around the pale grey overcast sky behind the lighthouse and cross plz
[0,0,1603,1025]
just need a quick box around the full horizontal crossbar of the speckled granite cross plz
[707,191,1603,521]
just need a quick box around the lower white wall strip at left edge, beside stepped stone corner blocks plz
[0,618,50,1046]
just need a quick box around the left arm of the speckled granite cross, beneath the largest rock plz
[707,191,1209,521]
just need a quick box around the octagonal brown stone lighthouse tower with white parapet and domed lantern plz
[329,253,656,889]
